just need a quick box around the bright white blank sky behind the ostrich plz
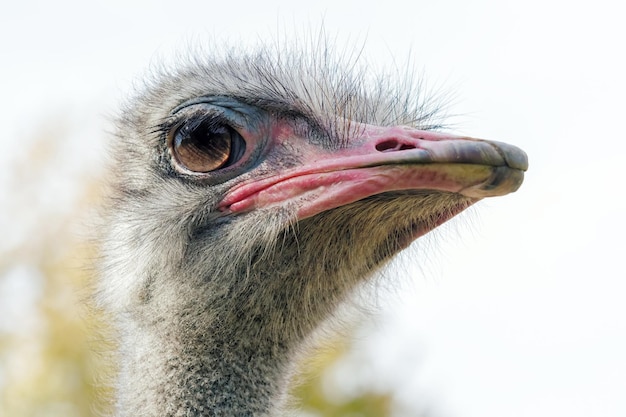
[0,0,626,417]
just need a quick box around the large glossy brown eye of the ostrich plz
[170,118,246,173]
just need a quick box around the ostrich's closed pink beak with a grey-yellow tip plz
[219,125,528,226]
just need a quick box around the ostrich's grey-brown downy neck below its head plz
[111,254,338,417]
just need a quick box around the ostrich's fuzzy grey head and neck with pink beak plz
[99,43,527,417]
